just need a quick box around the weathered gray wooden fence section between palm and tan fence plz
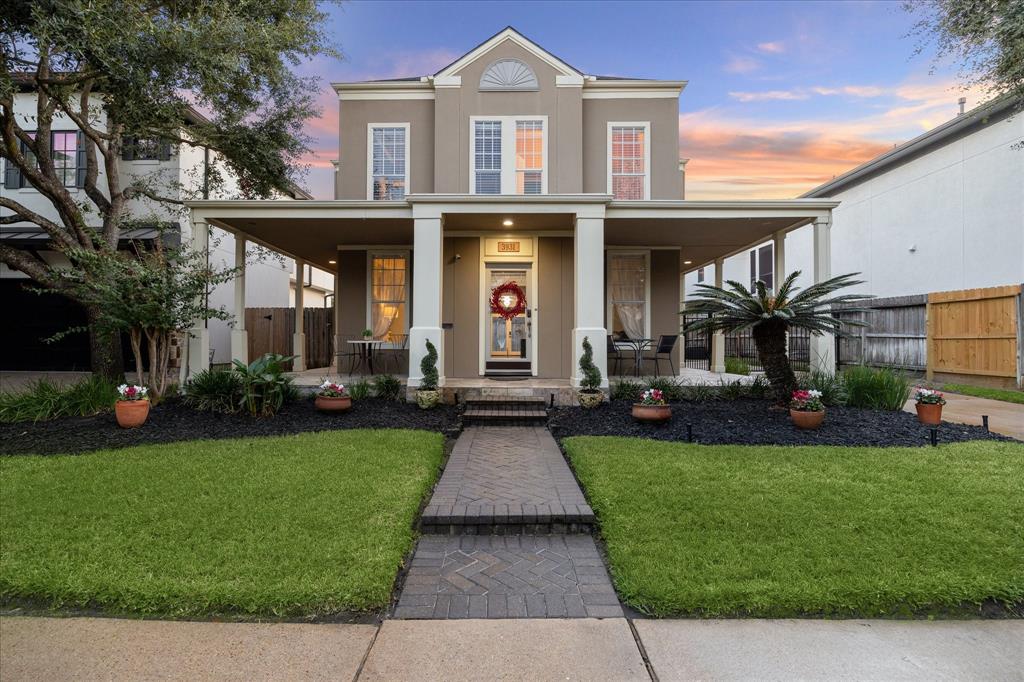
[836,294,928,372]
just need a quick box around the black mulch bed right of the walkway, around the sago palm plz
[548,399,1012,446]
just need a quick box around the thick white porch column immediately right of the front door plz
[572,211,608,388]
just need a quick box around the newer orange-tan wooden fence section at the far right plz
[928,285,1021,385]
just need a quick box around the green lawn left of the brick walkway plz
[0,430,443,617]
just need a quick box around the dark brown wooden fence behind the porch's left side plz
[246,308,334,368]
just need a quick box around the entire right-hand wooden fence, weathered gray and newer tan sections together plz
[835,285,1024,386]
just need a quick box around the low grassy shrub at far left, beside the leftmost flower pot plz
[0,375,118,422]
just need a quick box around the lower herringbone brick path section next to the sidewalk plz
[394,536,623,619]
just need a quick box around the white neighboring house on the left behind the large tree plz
[0,92,310,370]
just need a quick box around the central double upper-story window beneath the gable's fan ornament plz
[469,116,548,195]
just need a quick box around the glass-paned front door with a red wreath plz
[484,265,534,374]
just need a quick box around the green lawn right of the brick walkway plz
[563,436,1024,616]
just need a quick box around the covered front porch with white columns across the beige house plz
[187,195,837,393]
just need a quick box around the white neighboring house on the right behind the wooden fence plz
[686,97,1024,297]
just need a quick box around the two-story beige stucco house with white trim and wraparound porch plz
[189,28,838,399]
